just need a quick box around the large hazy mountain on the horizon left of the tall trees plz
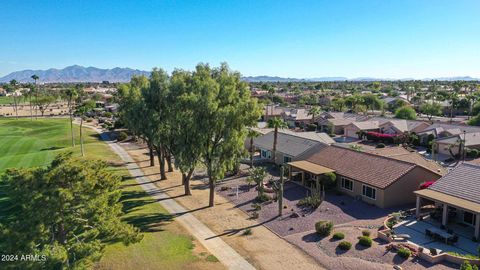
[0,65,150,83]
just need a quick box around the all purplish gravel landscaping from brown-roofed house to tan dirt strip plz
[217,174,458,270]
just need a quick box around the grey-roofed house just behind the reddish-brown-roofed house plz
[253,130,335,164]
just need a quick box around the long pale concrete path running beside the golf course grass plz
[96,131,255,270]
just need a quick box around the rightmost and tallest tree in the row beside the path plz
[192,63,261,207]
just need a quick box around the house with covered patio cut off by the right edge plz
[415,162,480,239]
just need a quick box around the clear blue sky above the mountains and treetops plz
[0,0,480,78]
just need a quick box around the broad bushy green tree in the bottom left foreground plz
[0,153,142,269]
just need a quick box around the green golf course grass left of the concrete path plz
[0,119,219,269]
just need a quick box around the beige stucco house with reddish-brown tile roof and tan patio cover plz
[289,144,442,208]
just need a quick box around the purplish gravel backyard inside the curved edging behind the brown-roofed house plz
[217,177,398,236]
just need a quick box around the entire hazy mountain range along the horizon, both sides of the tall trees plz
[0,65,480,83]
